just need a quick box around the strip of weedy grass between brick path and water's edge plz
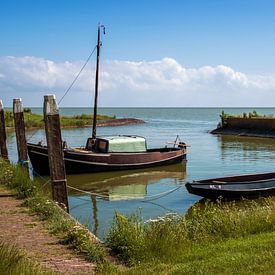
[0,158,112,266]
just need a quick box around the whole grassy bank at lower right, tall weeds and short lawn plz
[106,198,275,274]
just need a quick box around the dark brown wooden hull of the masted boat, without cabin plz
[28,143,186,175]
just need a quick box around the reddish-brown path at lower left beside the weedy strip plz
[0,187,95,274]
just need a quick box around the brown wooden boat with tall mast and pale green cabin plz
[27,25,187,175]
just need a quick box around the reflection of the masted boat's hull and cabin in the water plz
[67,163,186,201]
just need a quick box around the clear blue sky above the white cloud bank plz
[0,0,275,105]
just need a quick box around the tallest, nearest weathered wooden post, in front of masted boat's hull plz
[44,95,69,212]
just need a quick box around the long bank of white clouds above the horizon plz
[0,56,275,107]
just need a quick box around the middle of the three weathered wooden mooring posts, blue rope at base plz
[13,98,29,173]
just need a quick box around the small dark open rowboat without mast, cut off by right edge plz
[185,173,275,200]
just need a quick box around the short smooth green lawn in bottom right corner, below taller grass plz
[116,232,275,274]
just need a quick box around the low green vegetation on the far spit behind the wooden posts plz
[5,108,115,128]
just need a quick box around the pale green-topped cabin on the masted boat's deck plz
[86,136,147,153]
